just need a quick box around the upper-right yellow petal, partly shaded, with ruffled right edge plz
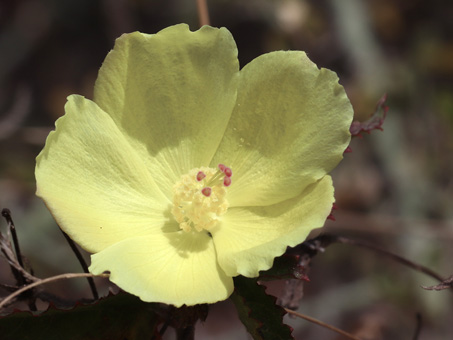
[212,51,353,206]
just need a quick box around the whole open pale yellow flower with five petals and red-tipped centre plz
[36,25,352,306]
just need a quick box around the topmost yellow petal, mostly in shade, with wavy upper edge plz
[94,25,239,199]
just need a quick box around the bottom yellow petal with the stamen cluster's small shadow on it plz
[89,231,233,307]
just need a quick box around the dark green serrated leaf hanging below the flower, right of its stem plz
[230,276,294,340]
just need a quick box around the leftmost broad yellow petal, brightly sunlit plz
[35,96,170,252]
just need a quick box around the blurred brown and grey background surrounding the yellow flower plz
[0,0,453,340]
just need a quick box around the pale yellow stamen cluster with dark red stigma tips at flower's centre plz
[171,164,233,232]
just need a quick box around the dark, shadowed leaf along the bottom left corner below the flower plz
[0,293,159,340]
